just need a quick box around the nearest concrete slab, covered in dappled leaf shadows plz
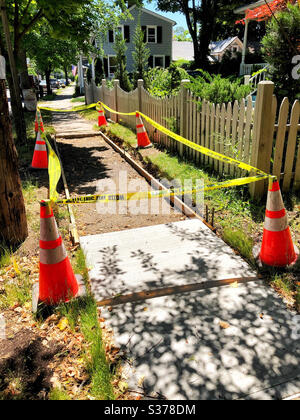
[101,282,300,400]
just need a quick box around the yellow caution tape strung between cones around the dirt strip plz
[38,102,276,204]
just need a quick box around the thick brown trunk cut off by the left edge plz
[0,80,28,247]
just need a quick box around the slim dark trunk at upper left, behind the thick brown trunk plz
[0,0,27,143]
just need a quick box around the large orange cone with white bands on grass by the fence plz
[257,180,299,267]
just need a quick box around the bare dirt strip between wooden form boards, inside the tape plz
[57,136,185,236]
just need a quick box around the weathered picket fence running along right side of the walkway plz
[86,80,300,197]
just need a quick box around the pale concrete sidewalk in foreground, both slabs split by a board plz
[81,220,300,400]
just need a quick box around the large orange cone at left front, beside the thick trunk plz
[39,201,79,305]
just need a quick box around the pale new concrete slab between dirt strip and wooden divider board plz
[80,216,256,300]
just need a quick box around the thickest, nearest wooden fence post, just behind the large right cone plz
[250,81,275,199]
